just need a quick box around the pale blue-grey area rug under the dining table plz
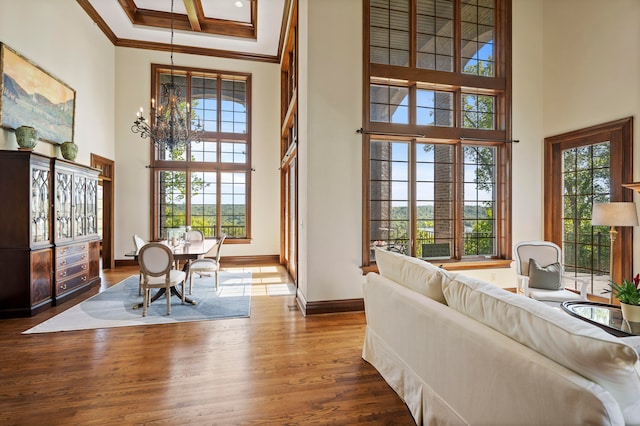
[23,272,251,334]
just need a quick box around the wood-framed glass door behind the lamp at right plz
[544,118,633,297]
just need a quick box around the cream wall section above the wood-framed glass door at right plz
[543,0,640,271]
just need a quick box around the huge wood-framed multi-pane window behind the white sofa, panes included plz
[363,0,511,265]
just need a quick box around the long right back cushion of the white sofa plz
[443,274,640,424]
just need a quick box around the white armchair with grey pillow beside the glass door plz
[514,241,588,306]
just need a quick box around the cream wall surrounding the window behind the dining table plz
[115,48,280,259]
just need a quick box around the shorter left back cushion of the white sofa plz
[376,247,453,303]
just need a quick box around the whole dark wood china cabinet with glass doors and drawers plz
[0,151,100,317]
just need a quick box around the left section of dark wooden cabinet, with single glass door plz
[0,151,53,317]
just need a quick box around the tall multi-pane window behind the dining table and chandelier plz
[152,65,251,242]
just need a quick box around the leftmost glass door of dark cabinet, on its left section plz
[31,166,51,243]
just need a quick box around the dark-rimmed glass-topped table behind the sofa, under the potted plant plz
[561,300,640,337]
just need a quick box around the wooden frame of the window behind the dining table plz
[149,64,253,244]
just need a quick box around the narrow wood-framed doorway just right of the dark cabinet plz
[91,154,115,269]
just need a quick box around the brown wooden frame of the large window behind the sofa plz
[362,0,512,272]
